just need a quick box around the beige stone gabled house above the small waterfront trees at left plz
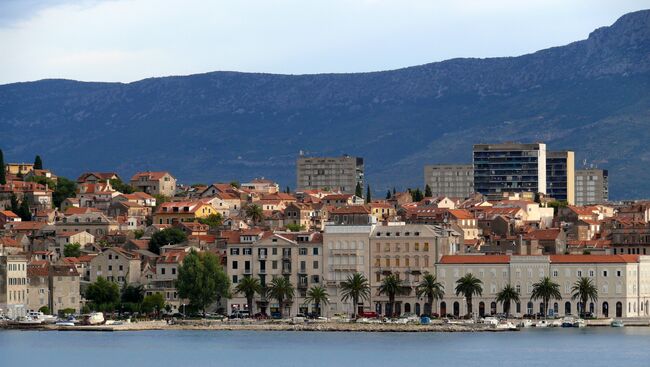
[88,247,141,285]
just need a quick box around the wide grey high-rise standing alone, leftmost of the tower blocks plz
[296,155,364,194]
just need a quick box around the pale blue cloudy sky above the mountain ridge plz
[0,0,650,84]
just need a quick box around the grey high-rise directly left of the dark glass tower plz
[424,164,474,198]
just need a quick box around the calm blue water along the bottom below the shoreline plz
[0,327,650,367]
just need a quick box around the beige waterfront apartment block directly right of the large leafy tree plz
[227,231,325,315]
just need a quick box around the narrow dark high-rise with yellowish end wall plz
[546,151,575,205]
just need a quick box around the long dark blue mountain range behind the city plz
[0,10,650,199]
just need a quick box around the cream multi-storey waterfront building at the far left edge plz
[0,253,27,319]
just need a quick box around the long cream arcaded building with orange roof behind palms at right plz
[436,255,650,317]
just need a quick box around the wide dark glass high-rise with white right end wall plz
[473,143,546,199]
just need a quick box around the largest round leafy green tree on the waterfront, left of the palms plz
[176,251,230,315]
